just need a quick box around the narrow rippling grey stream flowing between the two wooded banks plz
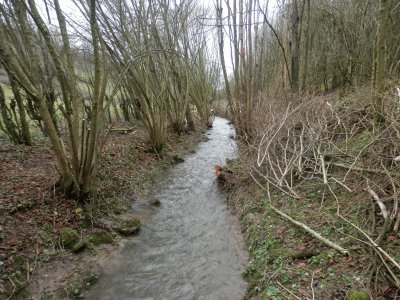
[86,118,246,300]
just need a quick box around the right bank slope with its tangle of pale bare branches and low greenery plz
[223,85,400,299]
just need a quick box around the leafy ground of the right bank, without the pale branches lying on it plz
[220,91,400,300]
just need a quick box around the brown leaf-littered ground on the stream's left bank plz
[0,121,205,299]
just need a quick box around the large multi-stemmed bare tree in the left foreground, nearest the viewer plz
[0,0,107,199]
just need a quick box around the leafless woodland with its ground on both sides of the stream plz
[0,0,400,300]
